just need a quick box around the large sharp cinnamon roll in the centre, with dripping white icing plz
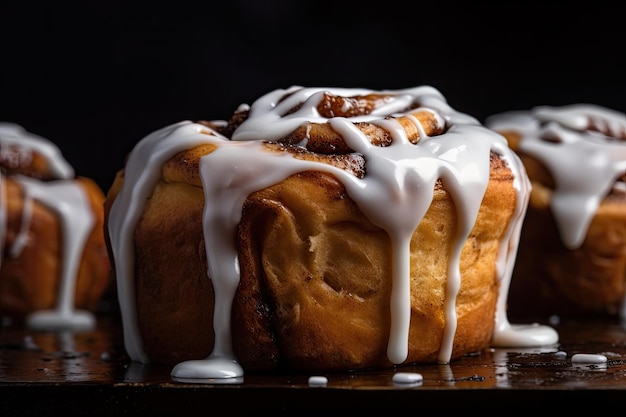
[105,86,558,381]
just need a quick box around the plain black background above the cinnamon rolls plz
[0,0,626,189]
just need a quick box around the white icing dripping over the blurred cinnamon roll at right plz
[485,104,626,249]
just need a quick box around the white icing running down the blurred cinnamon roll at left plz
[0,123,95,330]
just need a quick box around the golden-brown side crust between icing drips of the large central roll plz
[105,138,516,372]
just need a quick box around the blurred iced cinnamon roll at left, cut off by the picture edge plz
[0,123,111,330]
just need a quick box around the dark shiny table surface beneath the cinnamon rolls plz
[0,315,626,416]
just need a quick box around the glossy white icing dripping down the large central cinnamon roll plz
[108,86,558,381]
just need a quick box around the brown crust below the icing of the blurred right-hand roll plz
[501,130,626,318]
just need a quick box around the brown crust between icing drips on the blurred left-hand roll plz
[0,177,110,320]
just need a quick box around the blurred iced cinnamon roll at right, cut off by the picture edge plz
[485,104,626,317]
